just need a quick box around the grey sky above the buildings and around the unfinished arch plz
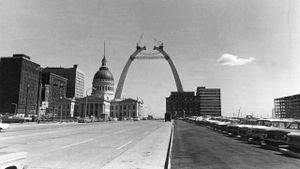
[0,0,300,117]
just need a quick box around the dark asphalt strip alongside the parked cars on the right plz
[171,120,300,169]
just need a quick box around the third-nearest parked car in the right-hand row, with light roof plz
[248,119,293,145]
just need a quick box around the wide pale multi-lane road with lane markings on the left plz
[0,121,165,169]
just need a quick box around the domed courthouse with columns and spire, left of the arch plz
[75,51,143,120]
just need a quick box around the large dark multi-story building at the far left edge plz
[0,54,40,115]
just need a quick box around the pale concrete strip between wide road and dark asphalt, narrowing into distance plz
[102,122,172,169]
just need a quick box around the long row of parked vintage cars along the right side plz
[185,116,300,158]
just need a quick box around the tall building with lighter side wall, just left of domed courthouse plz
[43,65,85,98]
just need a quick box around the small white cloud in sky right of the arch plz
[217,53,255,66]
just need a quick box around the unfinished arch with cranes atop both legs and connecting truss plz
[115,44,183,100]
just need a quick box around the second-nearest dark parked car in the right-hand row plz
[261,120,300,150]
